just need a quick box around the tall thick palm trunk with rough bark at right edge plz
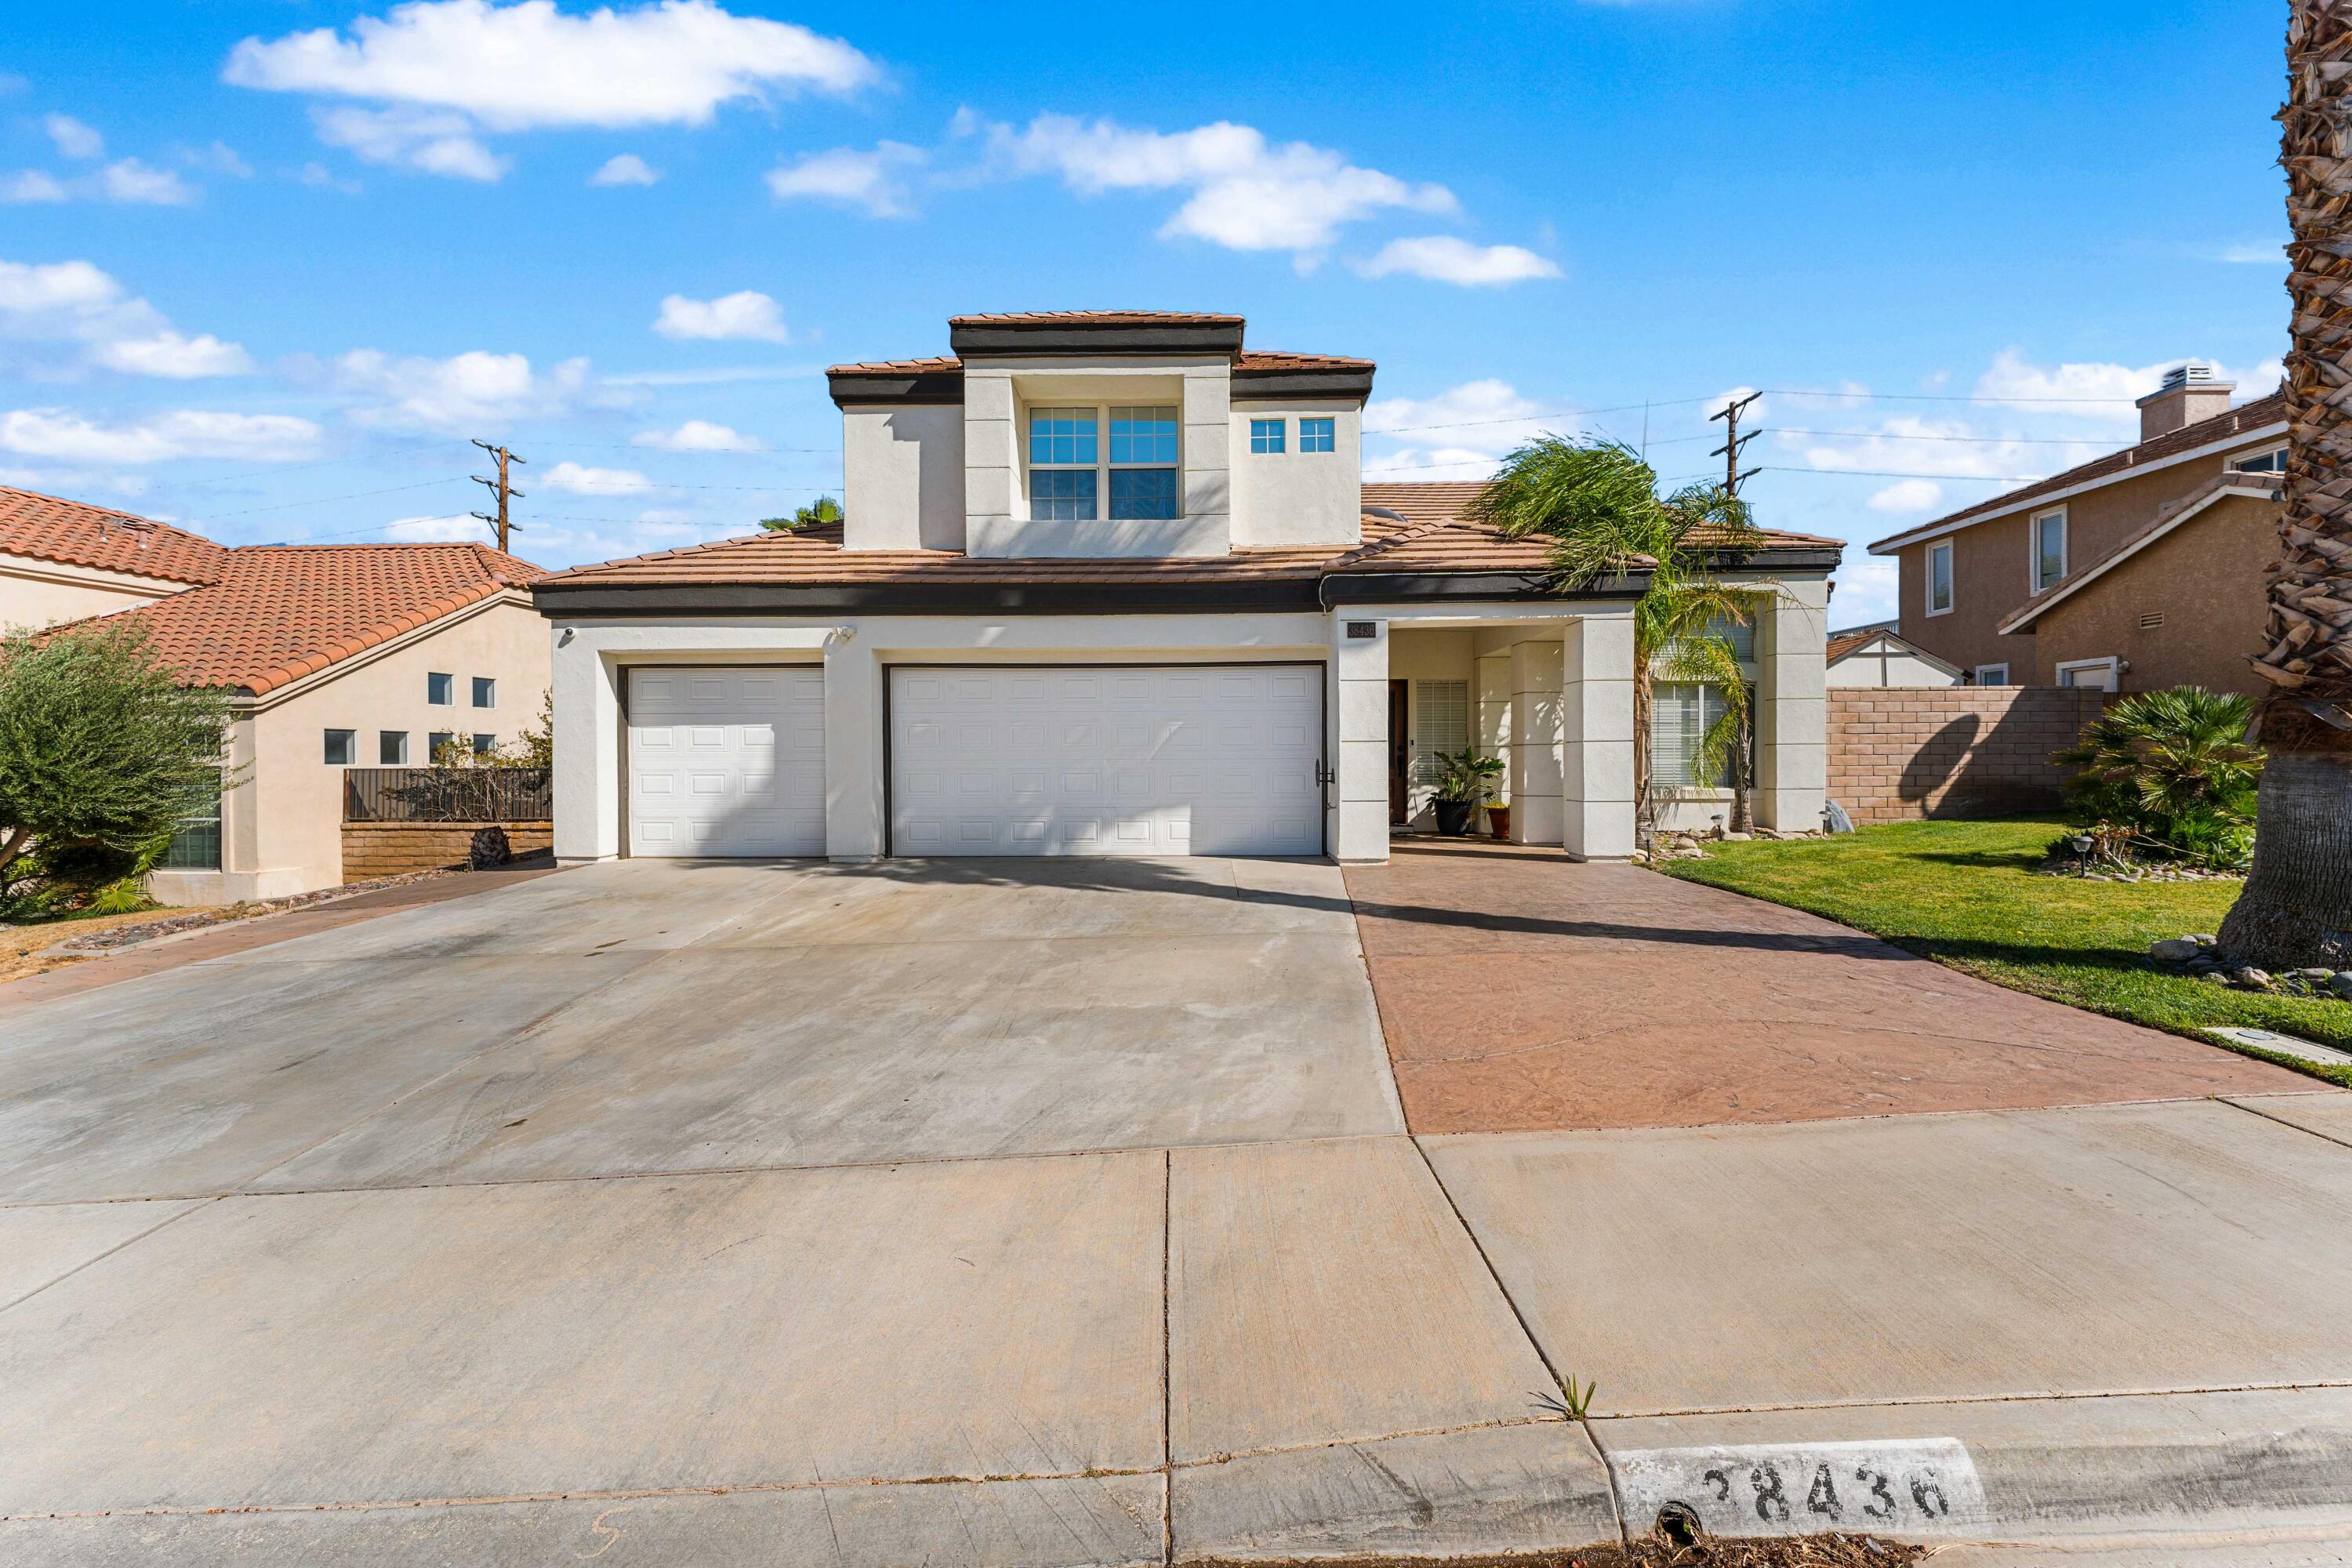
[2220,0,2352,968]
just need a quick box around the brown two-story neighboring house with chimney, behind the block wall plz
[1870,362,2286,691]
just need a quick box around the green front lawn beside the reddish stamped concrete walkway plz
[1663,818,2352,1088]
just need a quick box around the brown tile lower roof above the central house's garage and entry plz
[543,485,1839,586]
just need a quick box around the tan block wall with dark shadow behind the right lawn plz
[1830,687,2107,825]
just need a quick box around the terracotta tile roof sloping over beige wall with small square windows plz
[106,543,546,696]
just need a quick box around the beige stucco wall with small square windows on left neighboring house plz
[151,595,548,902]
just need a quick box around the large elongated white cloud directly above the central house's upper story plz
[988,115,1458,254]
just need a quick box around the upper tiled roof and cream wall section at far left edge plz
[0,487,228,630]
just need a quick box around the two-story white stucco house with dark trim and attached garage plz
[532,313,1837,862]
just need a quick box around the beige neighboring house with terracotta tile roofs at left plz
[0,492,548,905]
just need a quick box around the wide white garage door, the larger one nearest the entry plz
[889,666,1324,855]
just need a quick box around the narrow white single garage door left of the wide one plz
[628,666,826,858]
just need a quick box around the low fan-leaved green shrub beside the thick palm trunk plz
[2051,687,2263,867]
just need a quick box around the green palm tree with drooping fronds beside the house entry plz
[1468,439,1769,846]
